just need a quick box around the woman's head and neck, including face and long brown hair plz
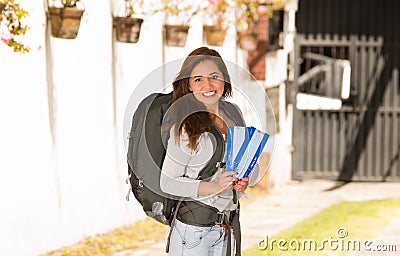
[173,47,234,150]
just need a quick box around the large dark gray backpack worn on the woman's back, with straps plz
[126,93,243,225]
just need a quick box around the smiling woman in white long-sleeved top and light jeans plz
[160,47,256,256]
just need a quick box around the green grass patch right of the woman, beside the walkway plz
[243,198,400,256]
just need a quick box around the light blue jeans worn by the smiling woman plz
[168,220,234,256]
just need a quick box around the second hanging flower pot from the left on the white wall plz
[114,17,143,43]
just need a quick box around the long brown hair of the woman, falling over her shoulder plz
[172,47,232,150]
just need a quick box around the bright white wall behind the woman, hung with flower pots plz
[0,0,294,255]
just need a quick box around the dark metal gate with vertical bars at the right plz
[293,0,400,181]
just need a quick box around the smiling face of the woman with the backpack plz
[189,60,225,108]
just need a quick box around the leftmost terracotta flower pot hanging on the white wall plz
[49,7,84,39]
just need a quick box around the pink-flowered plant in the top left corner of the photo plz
[0,0,31,53]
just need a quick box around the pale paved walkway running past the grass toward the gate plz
[114,180,400,256]
